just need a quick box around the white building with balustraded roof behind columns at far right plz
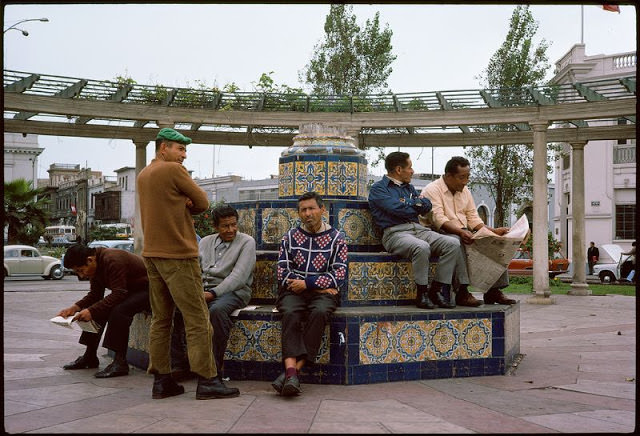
[553,44,636,260]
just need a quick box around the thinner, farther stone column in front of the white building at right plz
[568,142,591,295]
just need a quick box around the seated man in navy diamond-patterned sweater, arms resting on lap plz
[271,192,347,396]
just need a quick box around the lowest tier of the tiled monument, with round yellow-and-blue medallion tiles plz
[128,304,520,385]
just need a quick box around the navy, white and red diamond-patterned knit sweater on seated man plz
[278,227,347,290]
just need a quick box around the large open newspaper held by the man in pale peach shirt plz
[465,215,529,292]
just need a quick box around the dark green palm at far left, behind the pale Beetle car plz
[4,179,49,245]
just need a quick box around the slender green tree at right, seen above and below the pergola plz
[465,5,552,227]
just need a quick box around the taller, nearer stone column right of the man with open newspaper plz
[527,121,554,304]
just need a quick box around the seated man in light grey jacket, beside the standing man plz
[172,205,256,374]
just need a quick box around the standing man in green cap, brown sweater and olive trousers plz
[137,128,240,400]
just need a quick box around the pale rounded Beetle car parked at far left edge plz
[4,245,64,280]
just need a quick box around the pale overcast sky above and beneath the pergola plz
[3,4,636,179]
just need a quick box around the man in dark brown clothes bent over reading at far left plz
[58,244,151,378]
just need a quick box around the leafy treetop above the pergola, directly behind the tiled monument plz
[301,4,396,95]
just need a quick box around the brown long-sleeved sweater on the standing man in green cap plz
[136,159,209,259]
